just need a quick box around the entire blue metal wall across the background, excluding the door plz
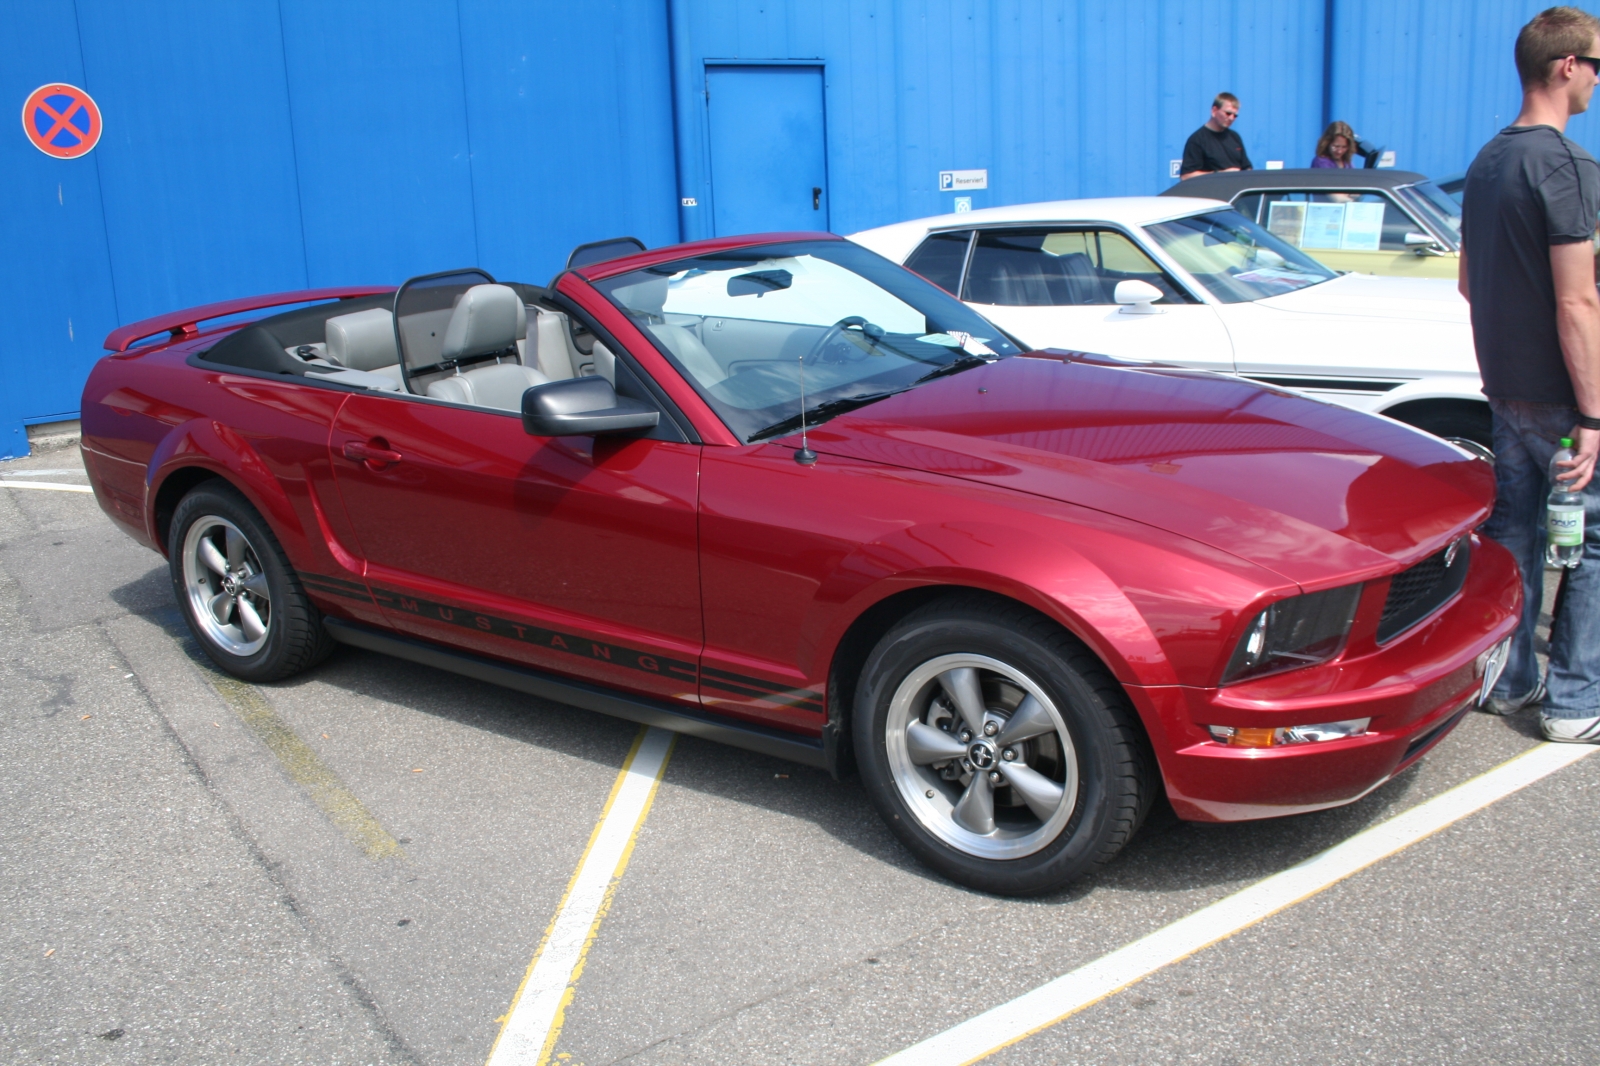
[0,0,1595,456]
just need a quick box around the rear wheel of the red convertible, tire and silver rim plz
[166,480,333,682]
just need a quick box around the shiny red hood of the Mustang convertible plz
[810,352,1494,589]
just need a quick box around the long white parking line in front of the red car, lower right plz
[878,744,1595,1066]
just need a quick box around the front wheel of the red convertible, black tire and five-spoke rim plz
[854,595,1157,895]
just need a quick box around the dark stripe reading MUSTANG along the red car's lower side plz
[299,573,824,714]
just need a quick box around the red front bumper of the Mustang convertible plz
[1128,538,1522,821]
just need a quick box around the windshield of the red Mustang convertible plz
[595,240,1018,440]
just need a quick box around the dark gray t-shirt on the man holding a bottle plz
[1461,126,1600,407]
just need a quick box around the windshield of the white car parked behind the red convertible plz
[1144,210,1334,304]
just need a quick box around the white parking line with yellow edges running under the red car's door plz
[476,727,677,1066]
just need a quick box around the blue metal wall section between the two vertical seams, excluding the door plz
[672,0,1323,237]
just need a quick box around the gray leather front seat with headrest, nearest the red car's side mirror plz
[427,285,549,411]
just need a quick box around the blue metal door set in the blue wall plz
[706,66,827,235]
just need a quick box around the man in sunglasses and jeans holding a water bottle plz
[1459,8,1600,743]
